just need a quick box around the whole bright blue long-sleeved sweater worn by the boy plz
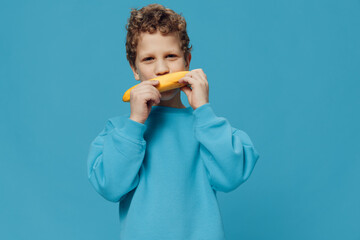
[87,103,259,240]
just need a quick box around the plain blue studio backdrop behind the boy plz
[0,0,360,240]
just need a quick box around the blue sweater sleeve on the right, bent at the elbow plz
[193,103,259,192]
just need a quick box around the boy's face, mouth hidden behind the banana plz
[132,31,191,100]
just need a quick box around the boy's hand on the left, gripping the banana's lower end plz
[130,80,161,124]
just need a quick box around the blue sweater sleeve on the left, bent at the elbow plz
[87,116,147,202]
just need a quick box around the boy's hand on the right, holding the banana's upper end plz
[178,68,209,110]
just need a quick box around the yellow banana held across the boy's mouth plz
[123,71,189,102]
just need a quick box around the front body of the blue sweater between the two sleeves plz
[120,111,223,239]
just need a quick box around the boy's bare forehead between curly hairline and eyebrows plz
[137,31,181,55]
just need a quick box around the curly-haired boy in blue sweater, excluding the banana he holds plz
[88,4,259,240]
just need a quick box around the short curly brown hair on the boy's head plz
[125,4,192,67]
